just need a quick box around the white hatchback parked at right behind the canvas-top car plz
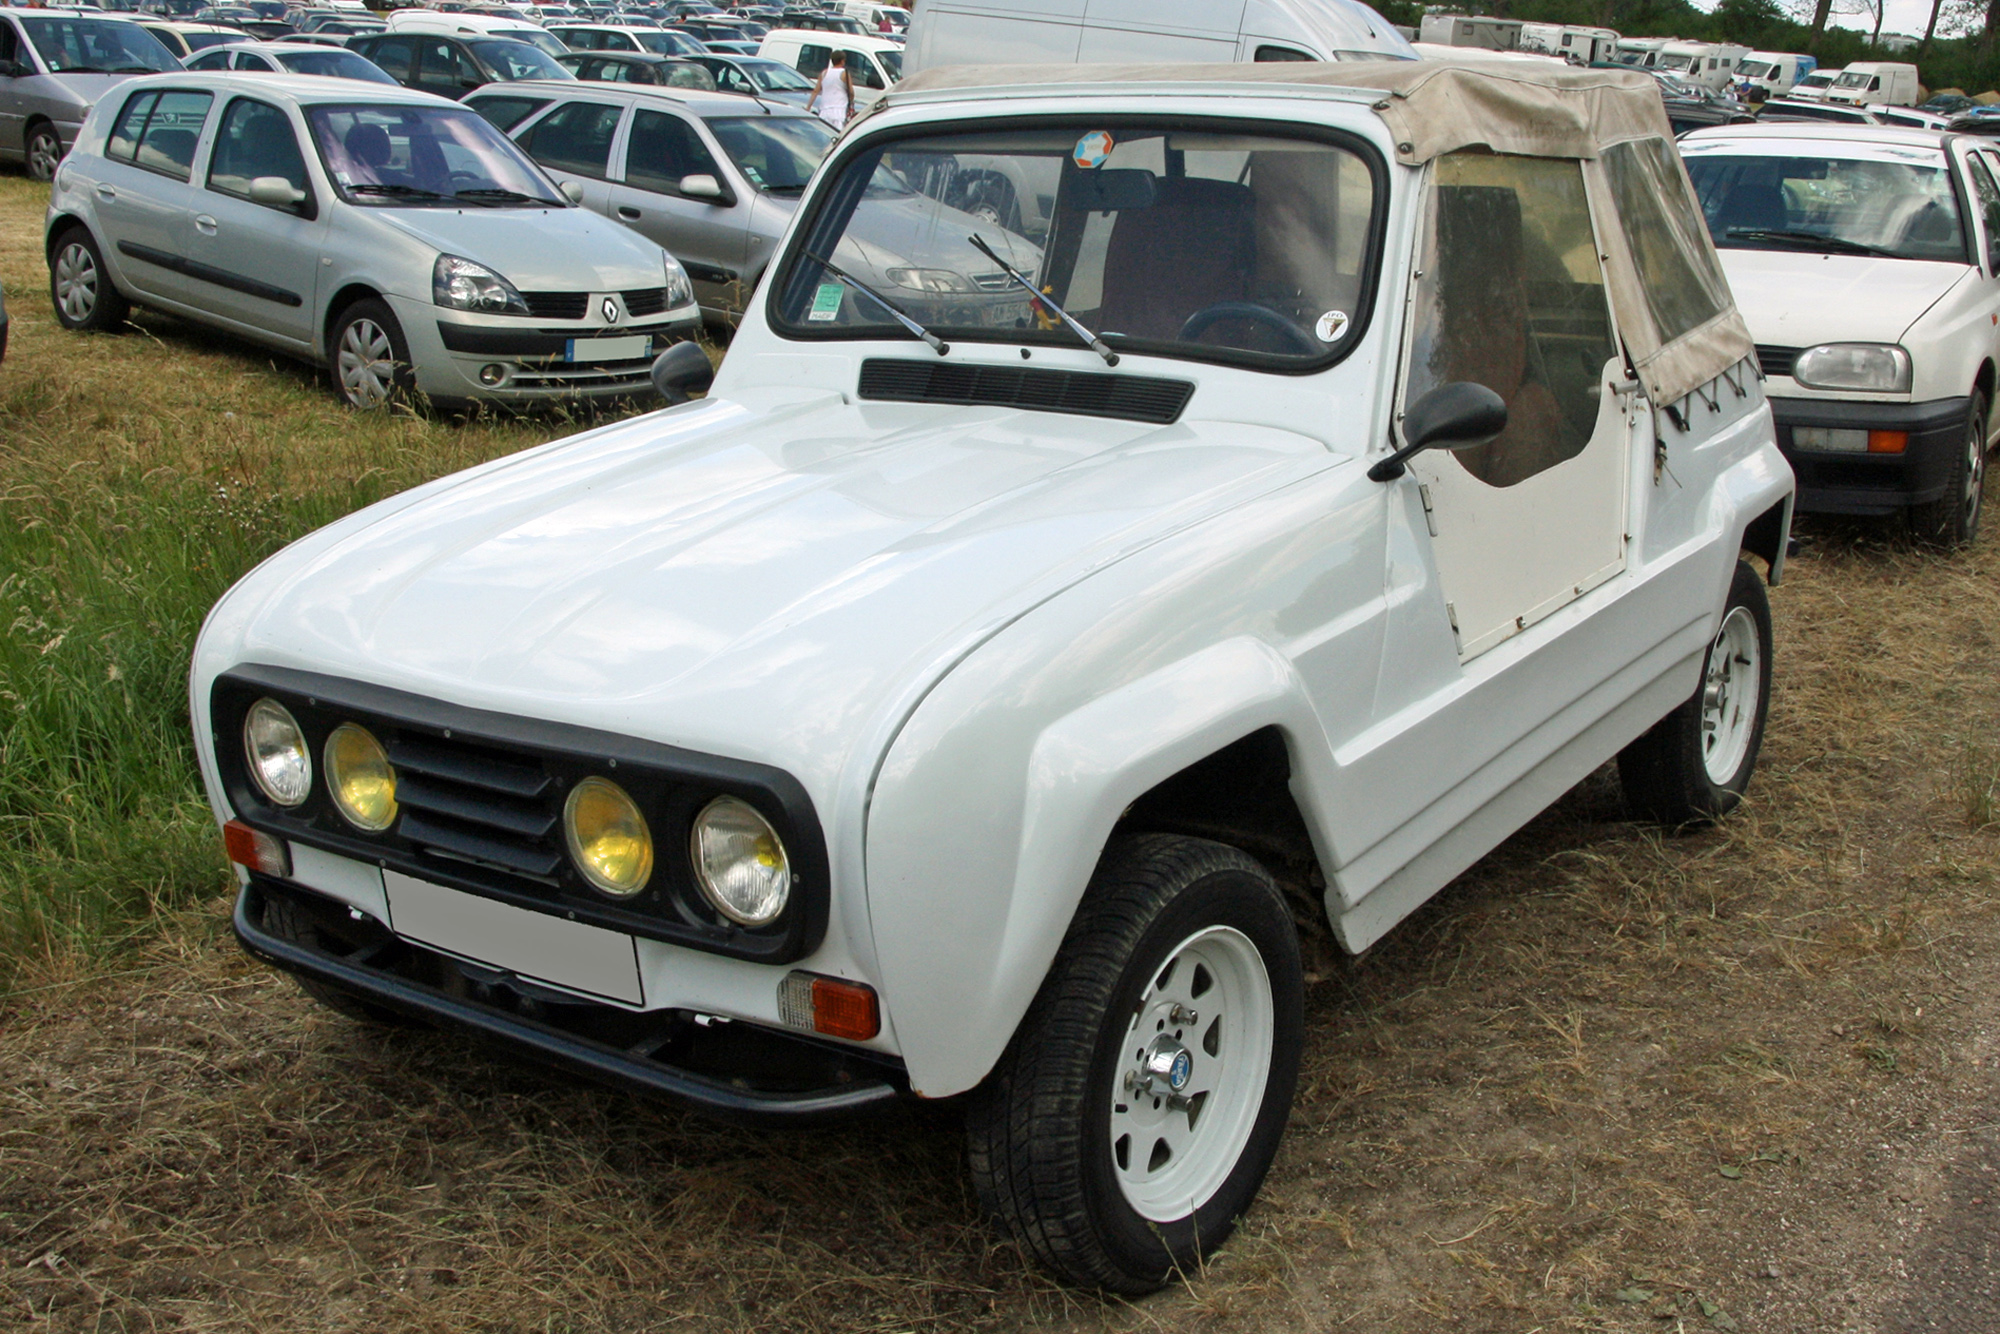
[1680,124,2000,546]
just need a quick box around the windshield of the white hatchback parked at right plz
[1688,152,1966,264]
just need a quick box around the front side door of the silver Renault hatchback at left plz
[188,98,330,352]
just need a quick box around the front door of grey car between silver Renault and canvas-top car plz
[610,106,754,310]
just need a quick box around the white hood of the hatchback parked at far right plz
[1716,250,1972,348]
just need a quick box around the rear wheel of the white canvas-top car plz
[1618,560,1772,828]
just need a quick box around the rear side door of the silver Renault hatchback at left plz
[92,88,214,304]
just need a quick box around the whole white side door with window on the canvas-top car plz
[1402,152,1634,664]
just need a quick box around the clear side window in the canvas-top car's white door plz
[1404,152,1616,486]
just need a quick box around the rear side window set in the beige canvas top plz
[1604,138,1730,346]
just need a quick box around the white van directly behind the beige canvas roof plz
[906,0,1416,74]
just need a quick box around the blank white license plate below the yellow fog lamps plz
[382,870,646,1006]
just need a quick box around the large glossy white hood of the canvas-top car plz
[202,390,1342,810]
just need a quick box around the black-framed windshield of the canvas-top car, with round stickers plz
[772,122,1380,368]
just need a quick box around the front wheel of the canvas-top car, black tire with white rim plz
[966,834,1304,1294]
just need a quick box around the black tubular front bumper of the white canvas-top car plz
[236,876,908,1126]
